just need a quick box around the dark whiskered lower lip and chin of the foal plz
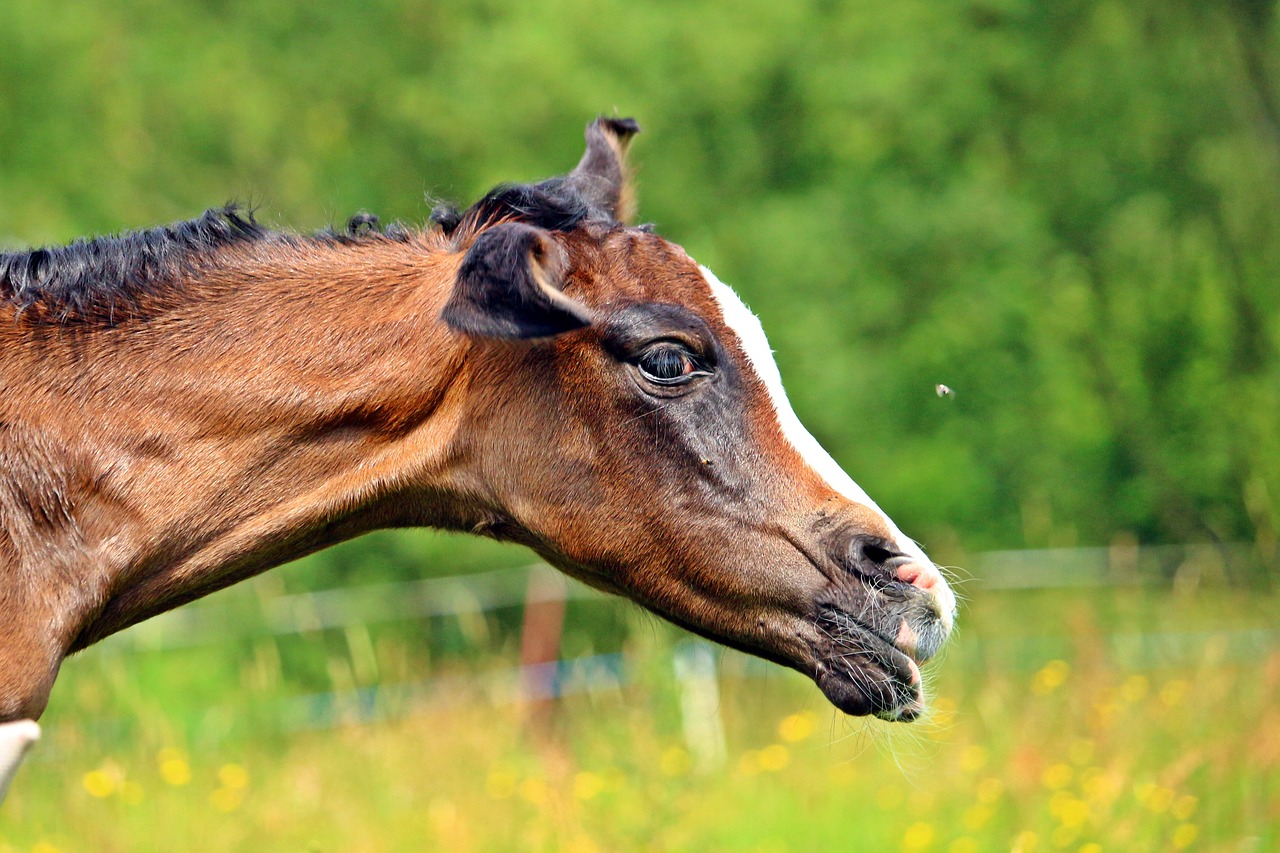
[814,608,924,722]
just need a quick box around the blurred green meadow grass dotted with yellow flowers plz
[0,573,1280,853]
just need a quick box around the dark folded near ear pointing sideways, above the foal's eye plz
[440,222,591,338]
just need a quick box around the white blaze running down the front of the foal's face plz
[699,265,955,628]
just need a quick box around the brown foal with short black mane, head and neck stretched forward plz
[0,119,955,788]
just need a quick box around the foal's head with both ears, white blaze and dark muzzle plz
[442,119,956,720]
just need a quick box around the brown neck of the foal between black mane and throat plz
[2,239,473,647]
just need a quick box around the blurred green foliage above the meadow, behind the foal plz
[0,0,1280,558]
